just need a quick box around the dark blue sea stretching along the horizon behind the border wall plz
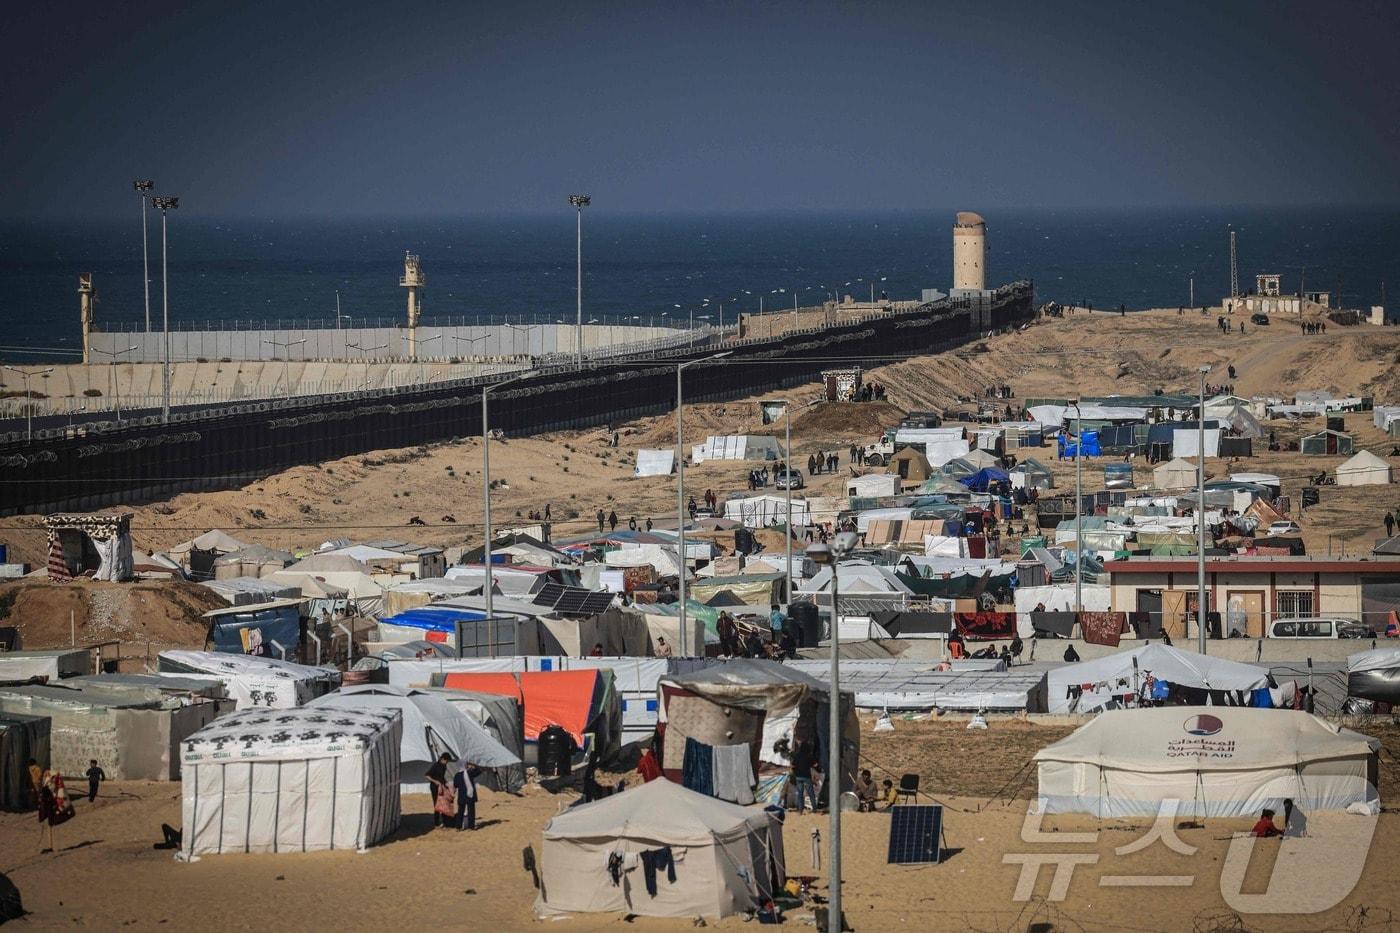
[0,205,1400,361]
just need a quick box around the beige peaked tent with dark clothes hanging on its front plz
[535,778,785,919]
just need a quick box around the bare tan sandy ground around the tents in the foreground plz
[8,711,1400,933]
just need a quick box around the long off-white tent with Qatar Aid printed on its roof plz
[1036,706,1380,817]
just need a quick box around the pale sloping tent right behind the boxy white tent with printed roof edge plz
[307,684,521,793]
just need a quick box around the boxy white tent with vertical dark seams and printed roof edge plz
[181,709,403,857]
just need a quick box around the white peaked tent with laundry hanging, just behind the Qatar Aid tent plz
[1046,644,1268,713]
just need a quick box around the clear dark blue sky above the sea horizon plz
[0,0,1400,219]
